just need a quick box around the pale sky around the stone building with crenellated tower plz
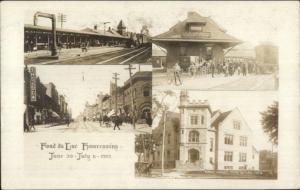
[153,90,278,150]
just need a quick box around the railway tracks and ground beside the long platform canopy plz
[25,47,151,65]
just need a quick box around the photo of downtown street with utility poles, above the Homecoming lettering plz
[24,64,152,134]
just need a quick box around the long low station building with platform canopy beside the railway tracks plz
[24,24,130,52]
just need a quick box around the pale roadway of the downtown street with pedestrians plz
[25,121,151,134]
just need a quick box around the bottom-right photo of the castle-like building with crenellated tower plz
[135,90,278,179]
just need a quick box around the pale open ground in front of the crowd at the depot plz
[152,73,275,90]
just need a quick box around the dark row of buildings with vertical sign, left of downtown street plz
[24,67,71,127]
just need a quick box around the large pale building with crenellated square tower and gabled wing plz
[153,91,259,171]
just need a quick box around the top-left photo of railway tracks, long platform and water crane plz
[24,11,152,65]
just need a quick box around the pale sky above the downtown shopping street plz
[35,65,151,118]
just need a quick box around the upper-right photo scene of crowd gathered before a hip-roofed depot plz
[151,11,279,90]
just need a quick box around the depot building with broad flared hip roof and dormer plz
[152,12,241,70]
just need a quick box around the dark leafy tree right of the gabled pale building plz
[260,101,278,145]
